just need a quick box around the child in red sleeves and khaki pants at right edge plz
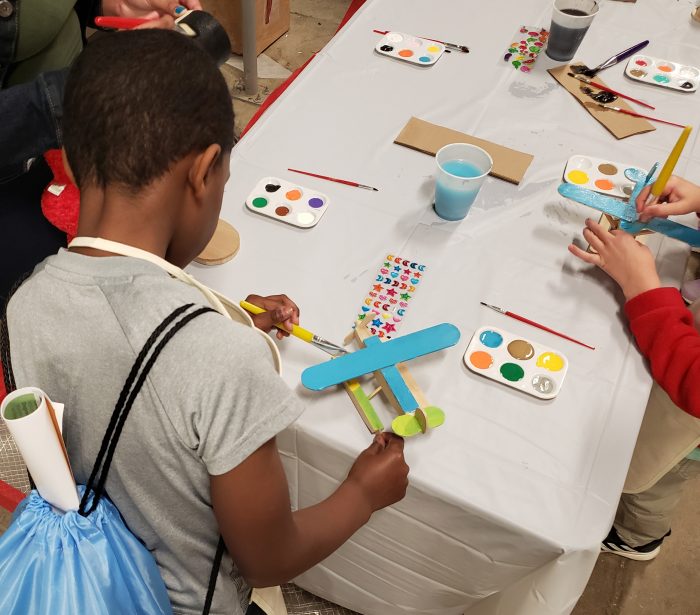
[569,176,700,560]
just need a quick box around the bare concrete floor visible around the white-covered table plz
[0,0,700,615]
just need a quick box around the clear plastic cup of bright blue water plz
[435,143,493,220]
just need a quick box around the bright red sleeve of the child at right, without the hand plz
[625,288,700,418]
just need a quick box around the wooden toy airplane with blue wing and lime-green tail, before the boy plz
[301,321,460,437]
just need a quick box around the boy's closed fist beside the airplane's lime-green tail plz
[347,432,408,512]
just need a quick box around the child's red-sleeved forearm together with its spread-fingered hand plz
[569,220,700,418]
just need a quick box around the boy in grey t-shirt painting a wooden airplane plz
[8,30,408,615]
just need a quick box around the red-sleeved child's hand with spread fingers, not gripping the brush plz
[569,218,661,300]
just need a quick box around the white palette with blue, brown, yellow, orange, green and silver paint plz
[463,326,569,399]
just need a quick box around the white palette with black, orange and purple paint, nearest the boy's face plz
[245,177,328,228]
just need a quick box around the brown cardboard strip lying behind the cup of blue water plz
[394,117,534,184]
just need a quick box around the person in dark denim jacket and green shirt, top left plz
[0,0,201,306]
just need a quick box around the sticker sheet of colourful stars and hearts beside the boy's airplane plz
[356,254,426,339]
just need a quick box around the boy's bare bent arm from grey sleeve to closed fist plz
[211,433,408,587]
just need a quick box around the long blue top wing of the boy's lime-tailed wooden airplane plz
[301,323,459,391]
